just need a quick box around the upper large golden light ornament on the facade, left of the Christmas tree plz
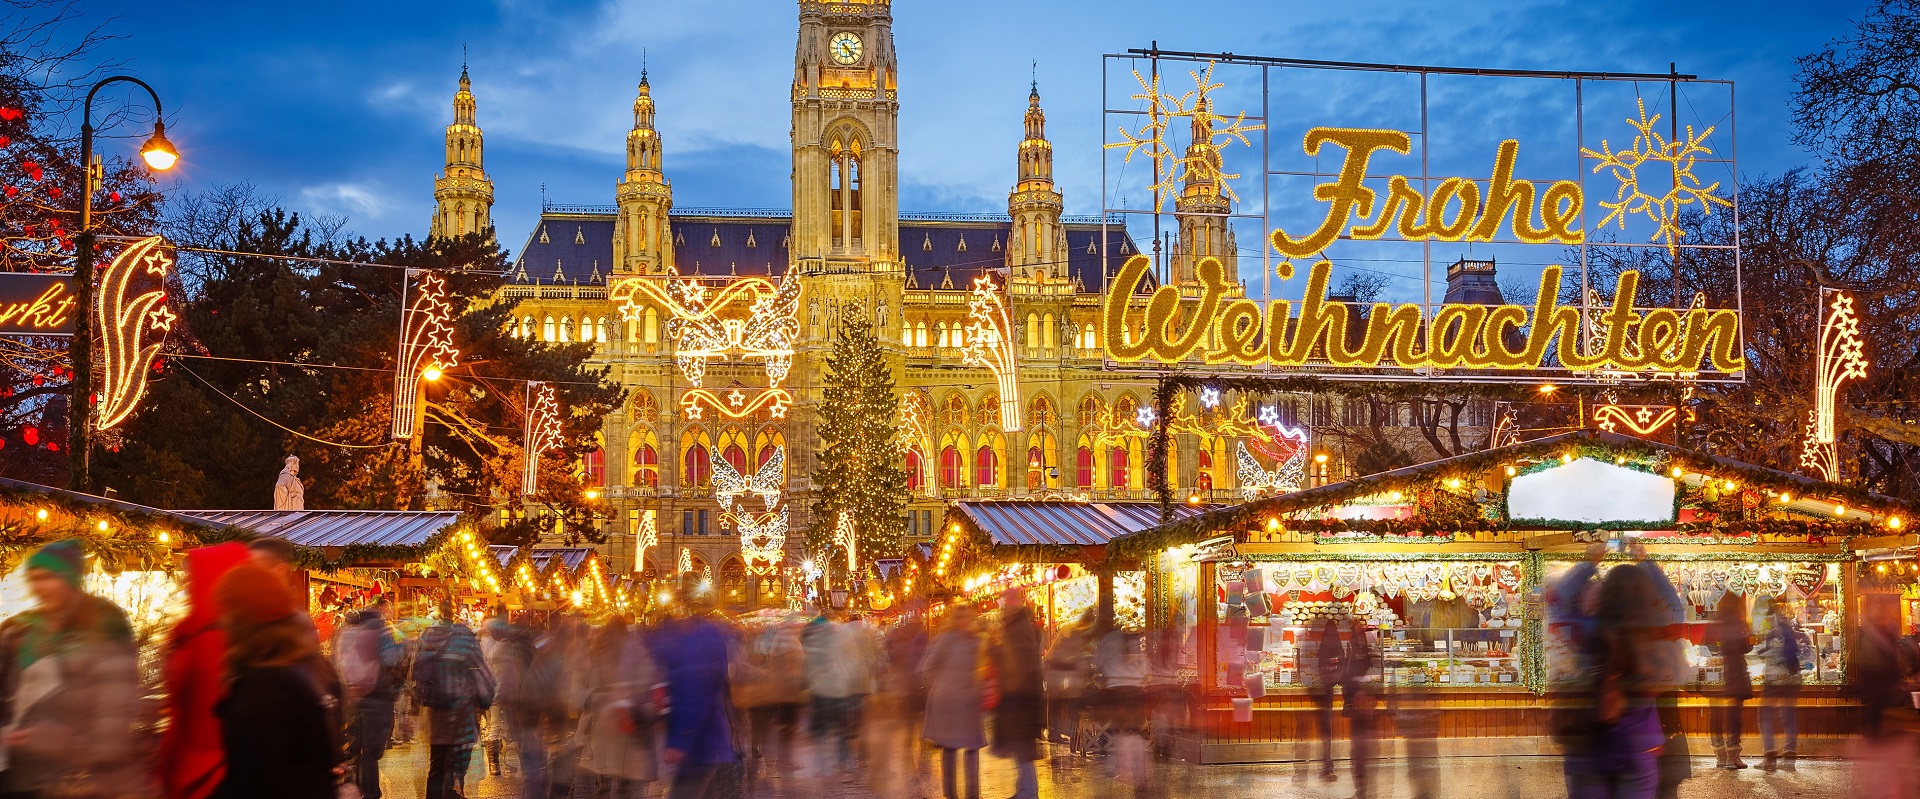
[607,273,801,419]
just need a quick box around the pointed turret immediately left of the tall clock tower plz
[612,67,674,275]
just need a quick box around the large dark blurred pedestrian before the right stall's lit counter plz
[1555,569,1667,799]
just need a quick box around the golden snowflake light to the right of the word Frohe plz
[1580,100,1734,255]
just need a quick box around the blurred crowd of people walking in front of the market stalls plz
[0,540,1920,799]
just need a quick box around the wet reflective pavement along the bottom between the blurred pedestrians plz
[382,729,1873,799]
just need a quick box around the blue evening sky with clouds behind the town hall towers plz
[83,0,1866,295]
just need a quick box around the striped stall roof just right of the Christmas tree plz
[952,499,1202,547]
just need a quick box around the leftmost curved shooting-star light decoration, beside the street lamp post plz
[95,236,177,432]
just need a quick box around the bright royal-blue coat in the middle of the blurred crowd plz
[649,617,733,766]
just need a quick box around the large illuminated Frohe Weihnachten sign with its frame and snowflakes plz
[1100,50,1745,384]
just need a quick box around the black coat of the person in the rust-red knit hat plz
[213,666,338,799]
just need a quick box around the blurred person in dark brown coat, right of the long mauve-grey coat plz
[993,590,1046,799]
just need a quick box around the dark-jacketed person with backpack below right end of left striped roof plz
[413,599,495,799]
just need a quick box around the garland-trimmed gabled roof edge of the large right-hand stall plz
[1116,430,1914,547]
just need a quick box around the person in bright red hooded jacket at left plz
[159,542,248,799]
